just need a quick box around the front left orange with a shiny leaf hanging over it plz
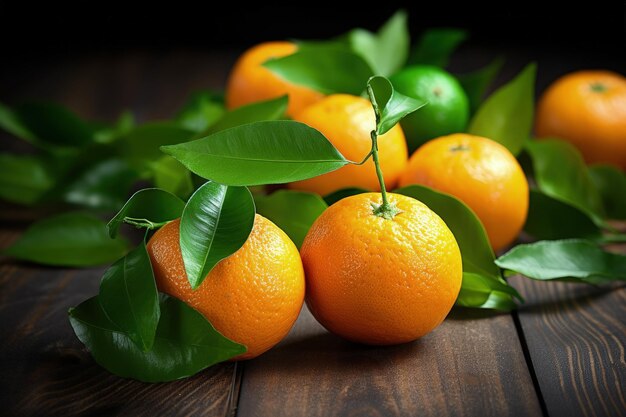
[148,214,305,360]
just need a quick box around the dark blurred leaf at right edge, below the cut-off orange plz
[589,165,626,220]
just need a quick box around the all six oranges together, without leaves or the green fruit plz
[148,42,626,359]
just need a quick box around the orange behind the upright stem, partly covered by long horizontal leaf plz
[288,94,408,195]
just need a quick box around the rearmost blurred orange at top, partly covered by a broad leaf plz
[226,42,324,116]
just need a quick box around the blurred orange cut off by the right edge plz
[535,71,626,170]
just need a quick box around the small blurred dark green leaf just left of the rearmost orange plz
[176,91,225,132]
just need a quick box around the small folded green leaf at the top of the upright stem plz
[367,75,427,135]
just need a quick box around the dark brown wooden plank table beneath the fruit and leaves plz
[0,51,626,417]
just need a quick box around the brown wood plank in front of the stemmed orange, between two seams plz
[237,309,541,417]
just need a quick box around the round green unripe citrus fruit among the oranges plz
[391,65,469,152]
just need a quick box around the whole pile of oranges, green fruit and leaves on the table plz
[0,12,626,381]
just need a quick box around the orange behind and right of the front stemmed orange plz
[400,133,528,251]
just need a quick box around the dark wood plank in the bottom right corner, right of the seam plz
[511,277,626,417]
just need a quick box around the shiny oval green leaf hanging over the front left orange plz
[180,182,255,289]
